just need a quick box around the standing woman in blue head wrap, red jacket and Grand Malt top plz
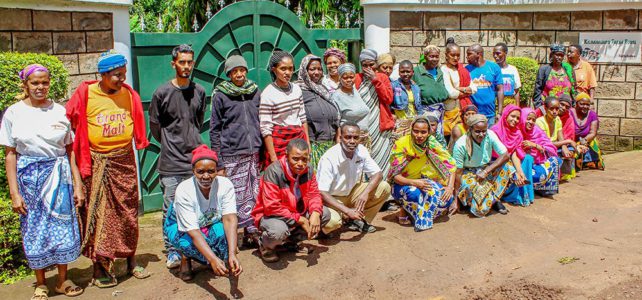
[65,51,149,288]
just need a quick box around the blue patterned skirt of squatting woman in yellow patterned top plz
[392,179,455,231]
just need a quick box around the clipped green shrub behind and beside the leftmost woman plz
[0,52,69,284]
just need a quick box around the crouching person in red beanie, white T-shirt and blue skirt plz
[163,145,243,281]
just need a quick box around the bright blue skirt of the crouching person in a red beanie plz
[163,203,228,264]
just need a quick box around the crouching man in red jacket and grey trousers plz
[252,139,330,262]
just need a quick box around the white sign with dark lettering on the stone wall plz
[580,32,642,64]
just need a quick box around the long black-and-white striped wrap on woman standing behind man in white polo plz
[359,80,392,178]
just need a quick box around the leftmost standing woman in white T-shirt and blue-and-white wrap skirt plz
[0,64,85,299]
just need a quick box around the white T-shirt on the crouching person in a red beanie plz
[174,176,236,232]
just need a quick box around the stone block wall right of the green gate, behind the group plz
[390,9,642,151]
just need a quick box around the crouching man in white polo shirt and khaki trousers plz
[317,122,390,233]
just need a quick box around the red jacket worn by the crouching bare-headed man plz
[252,157,323,227]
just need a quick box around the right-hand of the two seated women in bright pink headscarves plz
[520,107,560,203]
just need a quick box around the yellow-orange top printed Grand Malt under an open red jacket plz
[87,83,134,153]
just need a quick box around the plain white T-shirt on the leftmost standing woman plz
[0,101,74,157]
